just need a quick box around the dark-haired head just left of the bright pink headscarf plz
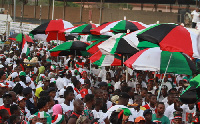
[37,97,49,112]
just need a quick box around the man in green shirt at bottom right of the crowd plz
[152,102,170,124]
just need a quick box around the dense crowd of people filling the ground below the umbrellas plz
[0,42,199,124]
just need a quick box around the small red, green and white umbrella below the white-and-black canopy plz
[89,51,122,66]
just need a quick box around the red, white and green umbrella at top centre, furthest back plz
[90,20,145,35]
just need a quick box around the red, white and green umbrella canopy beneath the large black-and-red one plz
[124,47,196,75]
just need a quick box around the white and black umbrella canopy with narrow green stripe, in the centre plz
[98,33,139,55]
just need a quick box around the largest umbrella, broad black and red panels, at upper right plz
[137,24,200,58]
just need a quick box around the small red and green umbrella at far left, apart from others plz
[8,33,34,43]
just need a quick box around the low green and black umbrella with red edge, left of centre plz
[50,41,88,56]
